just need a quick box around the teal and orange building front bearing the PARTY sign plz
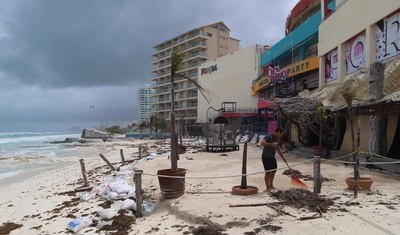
[251,0,324,135]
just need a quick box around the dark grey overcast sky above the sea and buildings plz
[0,0,298,131]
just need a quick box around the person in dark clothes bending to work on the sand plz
[261,127,285,192]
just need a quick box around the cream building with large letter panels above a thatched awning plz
[318,0,400,159]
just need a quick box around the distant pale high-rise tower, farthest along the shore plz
[136,84,154,125]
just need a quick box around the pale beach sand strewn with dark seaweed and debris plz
[0,138,400,235]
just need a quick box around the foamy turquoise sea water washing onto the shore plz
[0,131,90,179]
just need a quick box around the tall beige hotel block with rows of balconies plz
[151,22,240,124]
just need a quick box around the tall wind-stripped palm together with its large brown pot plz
[157,48,205,198]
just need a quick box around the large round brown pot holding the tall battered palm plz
[157,168,186,199]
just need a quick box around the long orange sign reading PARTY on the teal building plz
[251,56,319,94]
